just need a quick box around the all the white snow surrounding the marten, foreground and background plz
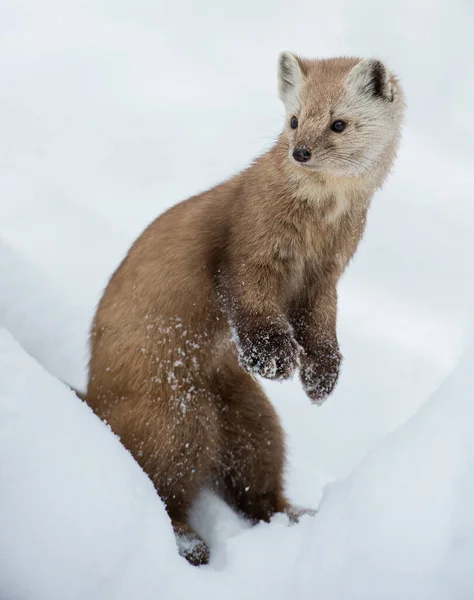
[0,0,474,600]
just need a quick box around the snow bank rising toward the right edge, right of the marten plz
[294,345,474,600]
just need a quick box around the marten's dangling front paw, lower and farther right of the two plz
[300,344,342,404]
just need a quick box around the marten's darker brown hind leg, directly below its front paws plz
[215,355,290,522]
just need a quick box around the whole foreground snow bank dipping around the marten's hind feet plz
[0,330,474,600]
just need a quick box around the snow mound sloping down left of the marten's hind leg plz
[0,329,184,600]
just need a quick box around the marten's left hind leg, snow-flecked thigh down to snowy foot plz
[102,388,219,565]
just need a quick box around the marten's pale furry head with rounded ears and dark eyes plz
[278,52,404,177]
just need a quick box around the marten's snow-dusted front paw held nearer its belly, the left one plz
[237,328,300,380]
